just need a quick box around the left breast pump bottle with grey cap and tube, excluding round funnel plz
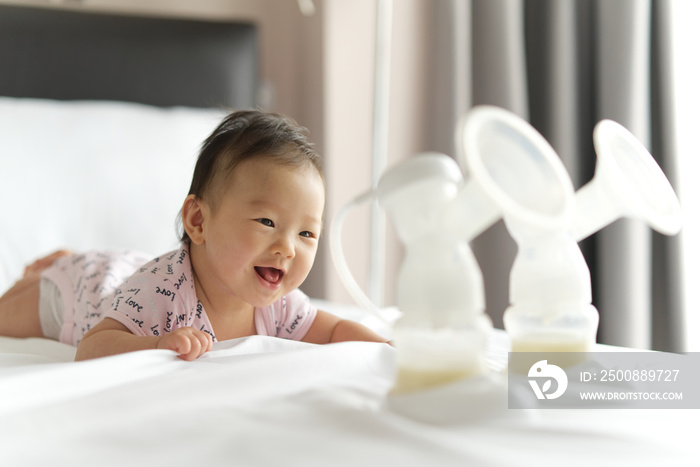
[331,153,499,392]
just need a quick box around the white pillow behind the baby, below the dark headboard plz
[0,97,225,293]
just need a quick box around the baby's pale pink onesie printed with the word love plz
[43,244,316,346]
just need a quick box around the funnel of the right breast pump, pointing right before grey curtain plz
[572,120,682,240]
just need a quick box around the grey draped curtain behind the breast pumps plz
[431,0,685,351]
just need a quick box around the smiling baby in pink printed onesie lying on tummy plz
[0,111,386,360]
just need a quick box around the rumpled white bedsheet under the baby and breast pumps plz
[0,334,700,467]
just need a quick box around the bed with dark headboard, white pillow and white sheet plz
[0,6,700,467]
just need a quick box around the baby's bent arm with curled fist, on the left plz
[75,318,212,361]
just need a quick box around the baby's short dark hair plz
[181,110,323,242]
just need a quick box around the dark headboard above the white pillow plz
[0,6,259,108]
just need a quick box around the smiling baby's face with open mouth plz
[204,159,325,307]
